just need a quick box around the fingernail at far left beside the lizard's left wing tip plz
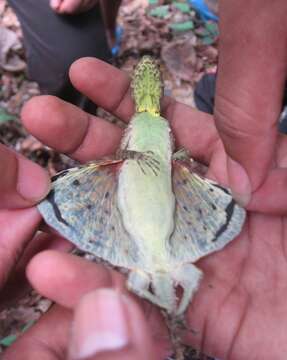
[17,157,50,202]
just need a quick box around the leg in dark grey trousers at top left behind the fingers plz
[8,0,110,111]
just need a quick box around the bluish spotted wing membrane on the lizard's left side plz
[38,163,139,268]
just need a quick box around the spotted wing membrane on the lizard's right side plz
[169,163,246,262]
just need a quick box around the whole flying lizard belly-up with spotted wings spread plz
[38,56,245,358]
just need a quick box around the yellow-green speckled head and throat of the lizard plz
[131,56,163,115]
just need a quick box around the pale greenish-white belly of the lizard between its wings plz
[118,114,175,270]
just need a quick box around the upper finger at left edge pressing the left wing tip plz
[0,144,50,209]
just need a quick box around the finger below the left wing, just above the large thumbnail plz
[27,250,121,308]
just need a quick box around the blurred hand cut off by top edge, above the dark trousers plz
[50,0,98,14]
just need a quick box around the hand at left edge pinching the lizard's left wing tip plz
[0,145,50,307]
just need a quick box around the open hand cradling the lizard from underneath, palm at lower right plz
[3,58,287,360]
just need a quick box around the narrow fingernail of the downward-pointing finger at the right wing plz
[227,157,251,207]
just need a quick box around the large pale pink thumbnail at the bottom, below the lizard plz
[71,289,129,359]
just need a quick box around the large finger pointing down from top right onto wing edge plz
[215,0,287,203]
